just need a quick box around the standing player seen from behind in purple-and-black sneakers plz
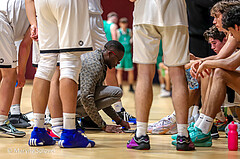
[127,0,195,150]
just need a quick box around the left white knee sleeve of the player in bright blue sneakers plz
[35,53,58,81]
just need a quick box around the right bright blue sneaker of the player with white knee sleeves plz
[58,129,95,148]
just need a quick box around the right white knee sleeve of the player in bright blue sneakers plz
[60,53,81,84]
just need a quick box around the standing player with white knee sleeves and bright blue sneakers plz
[26,0,95,147]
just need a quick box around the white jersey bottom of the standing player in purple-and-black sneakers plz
[133,0,188,26]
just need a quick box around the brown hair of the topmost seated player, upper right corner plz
[211,0,240,16]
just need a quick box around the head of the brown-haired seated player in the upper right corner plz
[211,0,240,32]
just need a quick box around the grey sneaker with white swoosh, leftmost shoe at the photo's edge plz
[0,120,26,137]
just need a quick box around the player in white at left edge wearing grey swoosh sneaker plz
[0,0,32,137]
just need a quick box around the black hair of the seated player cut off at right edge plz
[222,5,240,30]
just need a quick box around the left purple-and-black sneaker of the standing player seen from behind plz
[127,134,150,150]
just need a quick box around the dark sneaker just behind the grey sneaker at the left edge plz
[8,113,31,128]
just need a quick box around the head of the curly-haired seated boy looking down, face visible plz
[203,25,227,54]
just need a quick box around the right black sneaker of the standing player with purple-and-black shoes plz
[176,135,195,151]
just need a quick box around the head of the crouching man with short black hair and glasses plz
[103,40,125,69]
